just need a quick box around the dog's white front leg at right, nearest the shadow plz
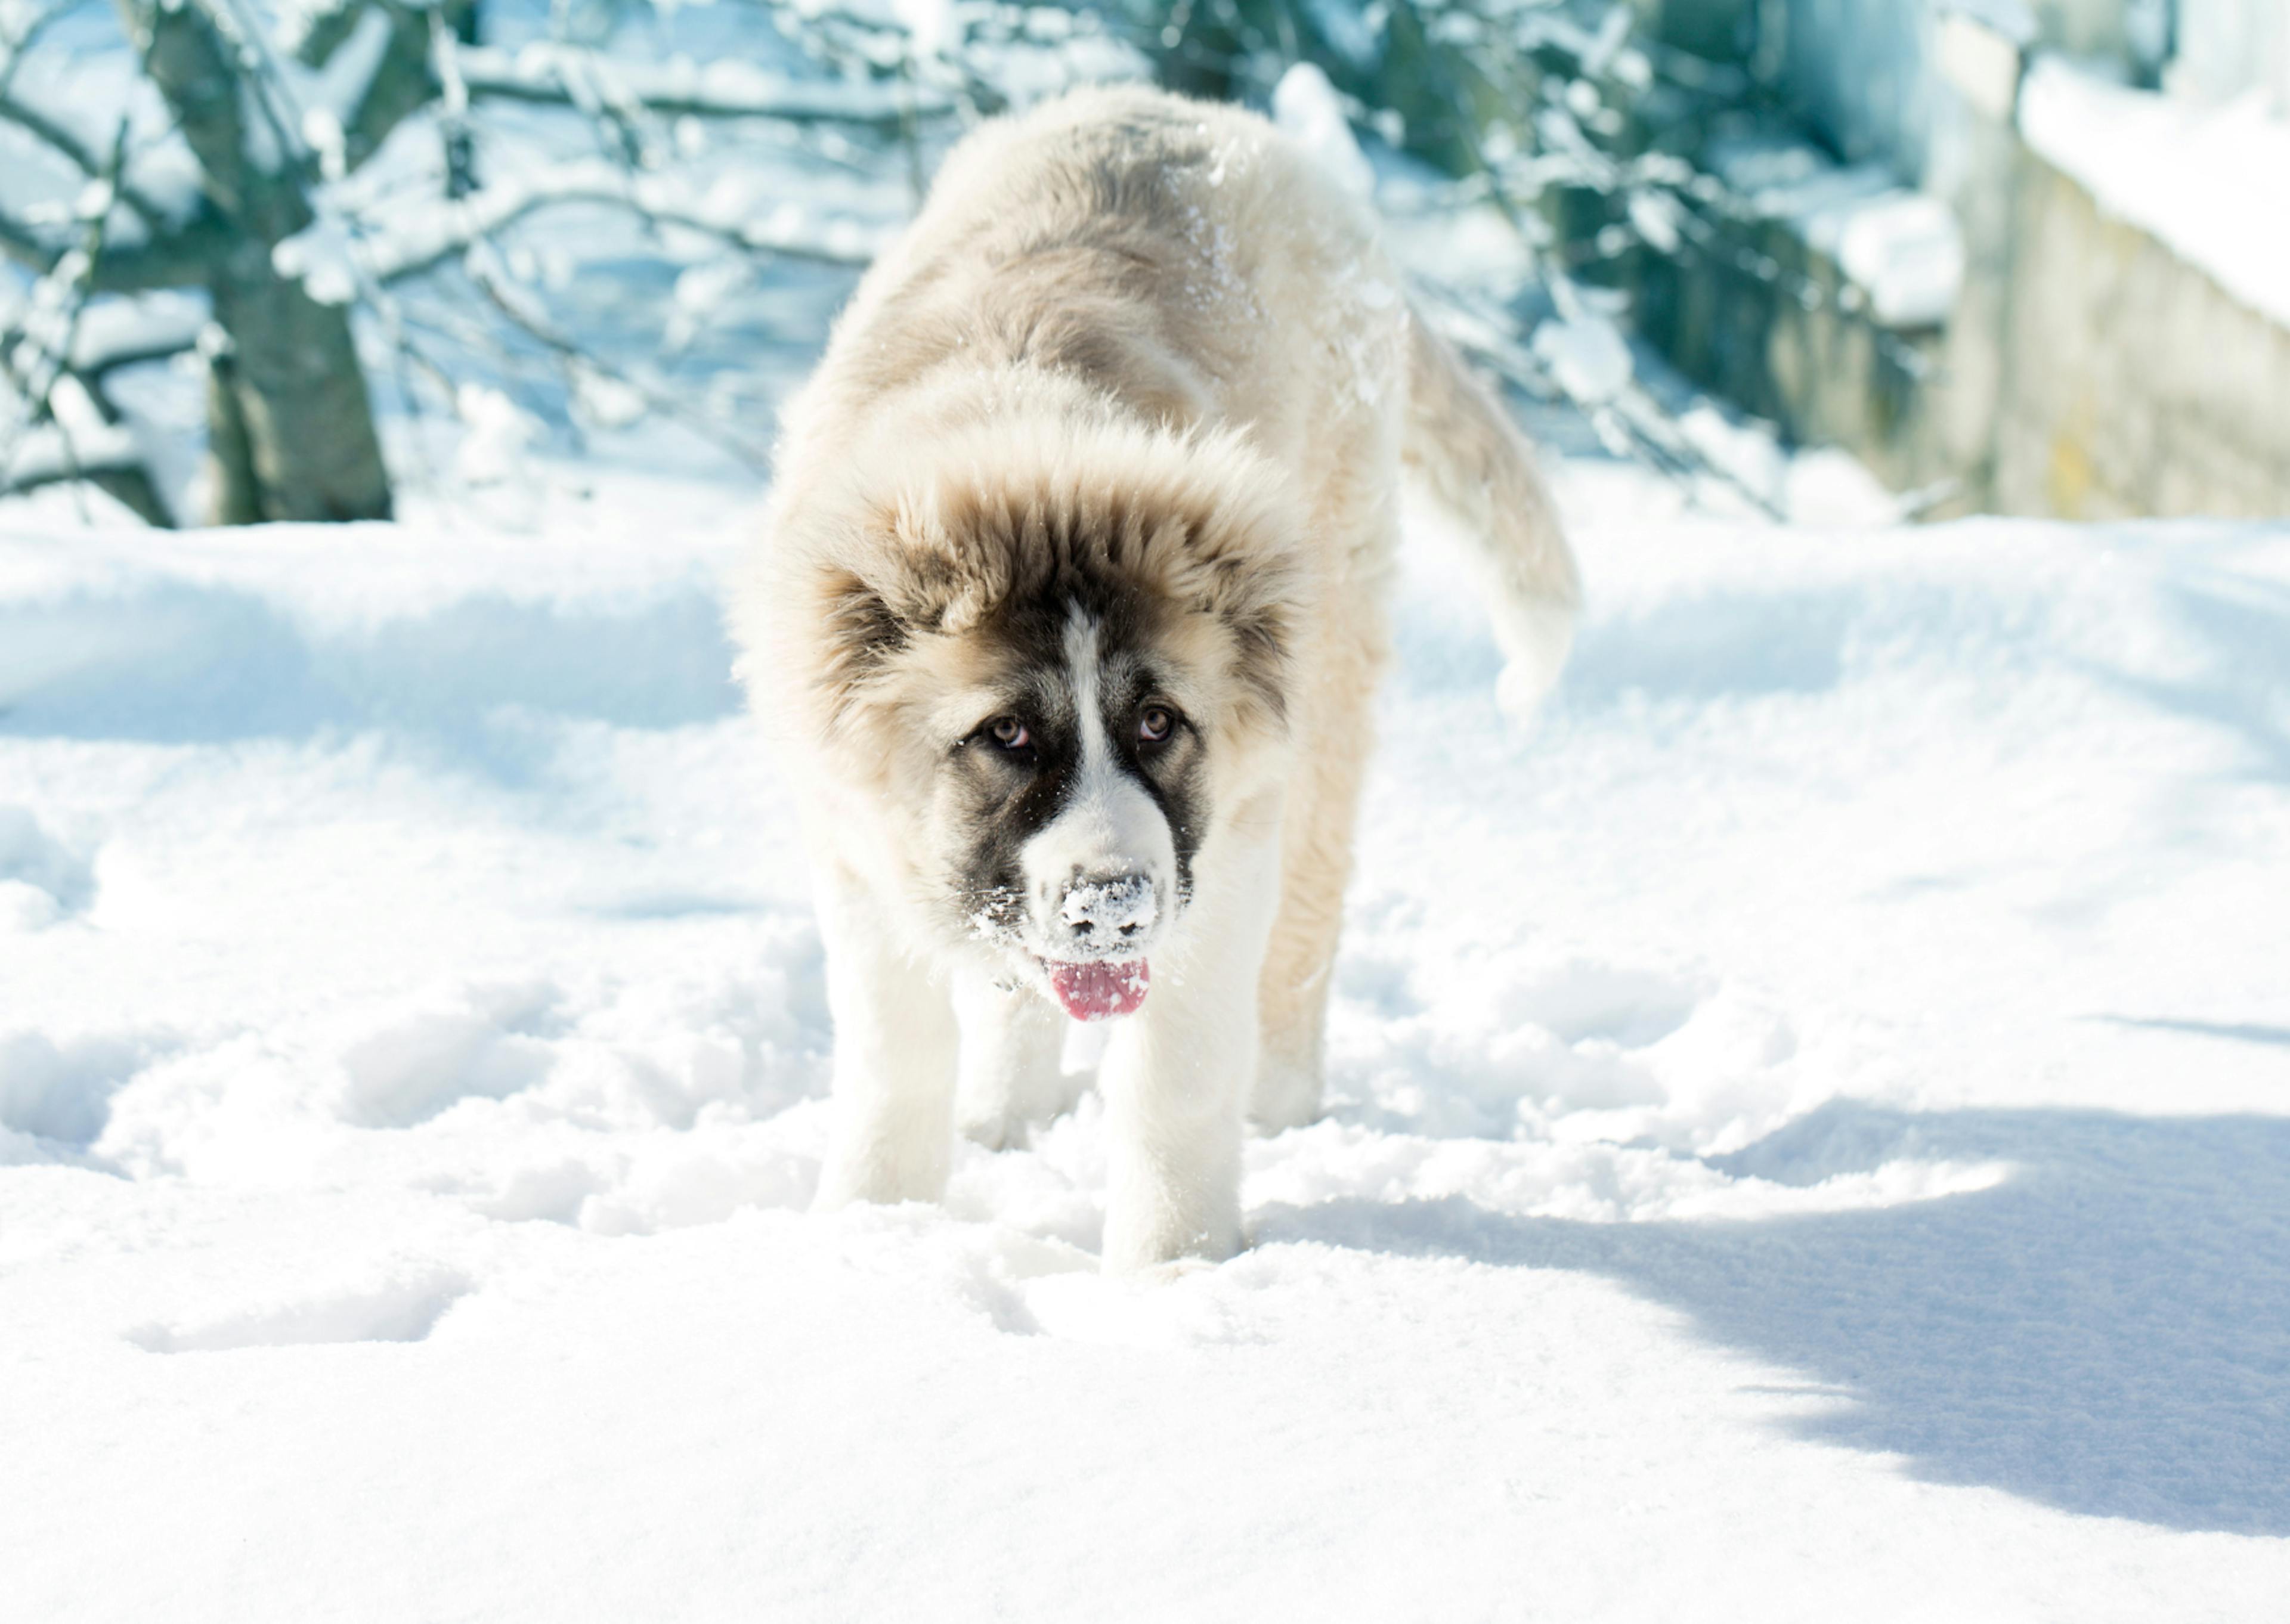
[1101,808,1280,1273]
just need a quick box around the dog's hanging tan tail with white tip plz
[1406,312,1582,717]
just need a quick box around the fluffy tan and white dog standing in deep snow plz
[731,87,1578,1273]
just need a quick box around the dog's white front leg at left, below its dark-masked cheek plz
[815,866,955,1210]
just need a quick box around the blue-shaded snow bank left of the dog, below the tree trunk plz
[0,527,737,742]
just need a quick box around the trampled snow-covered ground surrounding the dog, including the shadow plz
[0,453,2290,1622]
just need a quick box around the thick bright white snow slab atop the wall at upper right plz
[2020,57,2290,326]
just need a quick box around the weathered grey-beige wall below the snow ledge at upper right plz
[1630,16,2290,517]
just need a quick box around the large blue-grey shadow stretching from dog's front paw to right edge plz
[1255,1102,2290,1535]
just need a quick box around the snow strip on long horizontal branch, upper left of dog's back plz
[456,44,955,131]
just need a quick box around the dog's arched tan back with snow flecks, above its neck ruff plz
[783,87,1406,531]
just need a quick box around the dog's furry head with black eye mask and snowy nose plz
[756,419,1308,1019]
